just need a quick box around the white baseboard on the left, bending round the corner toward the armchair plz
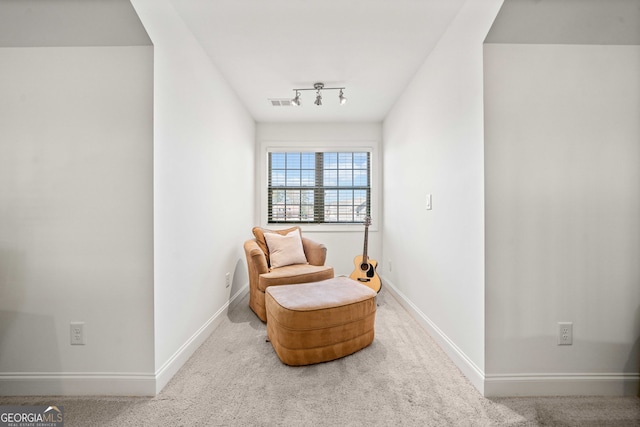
[0,284,249,396]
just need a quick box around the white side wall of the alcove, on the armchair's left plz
[133,0,255,391]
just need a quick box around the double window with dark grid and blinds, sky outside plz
[267,151,371,224]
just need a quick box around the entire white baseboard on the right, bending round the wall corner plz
[383,279,640,397]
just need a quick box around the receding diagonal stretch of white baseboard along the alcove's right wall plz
[383,278,484,393]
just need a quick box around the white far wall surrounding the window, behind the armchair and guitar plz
[256,123,382,275]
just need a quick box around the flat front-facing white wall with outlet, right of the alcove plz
[485,44,640,395]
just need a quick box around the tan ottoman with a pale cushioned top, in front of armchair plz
[265,277,376,366]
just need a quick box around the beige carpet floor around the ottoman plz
[0,288,640,427]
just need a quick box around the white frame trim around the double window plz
[257,141,382,232]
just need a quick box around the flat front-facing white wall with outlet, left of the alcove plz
[0,45,154,395]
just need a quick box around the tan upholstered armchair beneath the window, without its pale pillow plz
[244,227,334,322]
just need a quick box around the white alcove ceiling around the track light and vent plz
[166,0,464,122]
